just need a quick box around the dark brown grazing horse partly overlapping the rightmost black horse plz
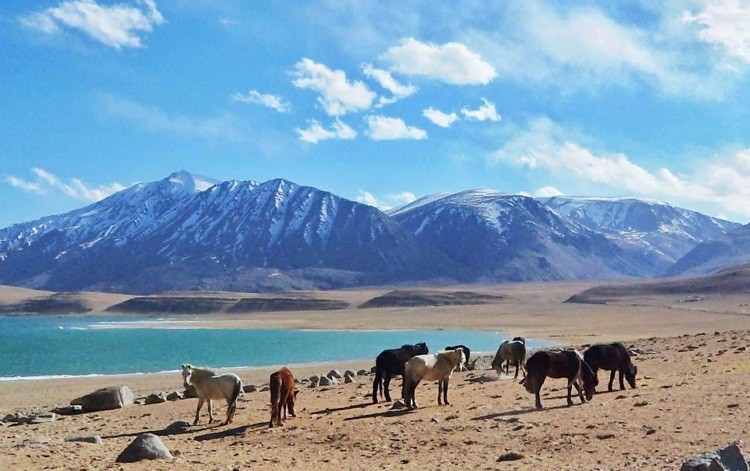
[521,350,599,409]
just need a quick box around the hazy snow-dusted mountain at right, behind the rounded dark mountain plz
[540,196,739,276]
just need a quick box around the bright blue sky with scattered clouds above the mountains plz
[0,0,750,227]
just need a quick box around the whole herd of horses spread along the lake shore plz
[182,337,638,427]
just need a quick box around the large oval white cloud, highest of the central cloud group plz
[381,38,497,85]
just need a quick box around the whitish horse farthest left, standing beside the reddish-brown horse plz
[182,364,242,425]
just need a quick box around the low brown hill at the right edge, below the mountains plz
[565,265,750,304]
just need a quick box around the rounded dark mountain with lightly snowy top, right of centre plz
[390,190,639,281]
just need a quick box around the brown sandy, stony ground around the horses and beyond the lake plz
[0,285,750,470]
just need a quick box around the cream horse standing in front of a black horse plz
[401,348,466,409]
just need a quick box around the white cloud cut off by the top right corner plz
[683,0,750,62]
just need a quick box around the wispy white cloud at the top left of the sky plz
[19,0,164,49]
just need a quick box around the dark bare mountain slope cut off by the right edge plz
[664,224,750,276]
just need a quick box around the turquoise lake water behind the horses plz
[0,316,552,380]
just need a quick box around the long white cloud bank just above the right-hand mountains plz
[488,118,750,219]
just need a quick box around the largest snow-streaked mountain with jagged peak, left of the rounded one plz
[0,172,456,292]
